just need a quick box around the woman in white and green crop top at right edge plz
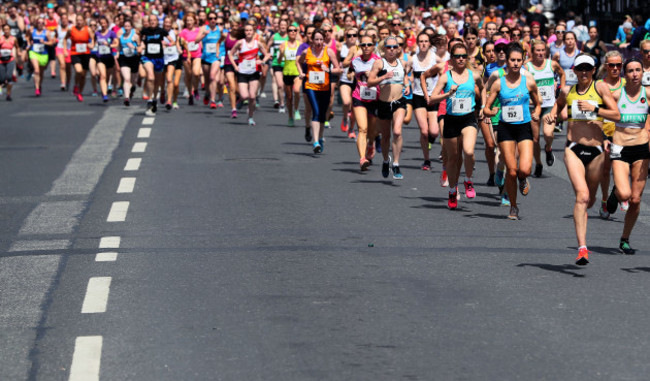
[607,58,650,255]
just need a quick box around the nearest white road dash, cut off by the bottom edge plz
[68,336,103,381]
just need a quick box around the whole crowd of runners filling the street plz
[0,0,650,265]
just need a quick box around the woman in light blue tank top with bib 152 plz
[484,43,541,220]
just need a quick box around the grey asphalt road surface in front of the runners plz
[0,78,650,381]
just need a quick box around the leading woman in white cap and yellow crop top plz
[546,54,620,266]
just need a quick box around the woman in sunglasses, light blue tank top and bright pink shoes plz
[429,44,483,210]
